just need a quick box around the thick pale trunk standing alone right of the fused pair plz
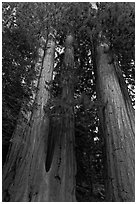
[96,44,135,202]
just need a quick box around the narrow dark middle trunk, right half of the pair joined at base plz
[46,33,76,202]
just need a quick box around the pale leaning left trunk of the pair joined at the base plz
[3,27,55,202]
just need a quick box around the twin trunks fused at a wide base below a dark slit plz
[3,30,76,202]
